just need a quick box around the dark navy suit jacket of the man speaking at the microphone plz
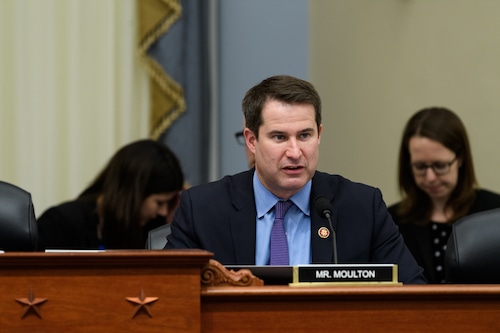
[166,170,426,283]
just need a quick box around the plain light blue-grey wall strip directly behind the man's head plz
[218,0,309,177]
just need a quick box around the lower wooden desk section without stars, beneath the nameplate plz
[201,285,500,333]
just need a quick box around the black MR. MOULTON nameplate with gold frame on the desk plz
[292,264,399,285]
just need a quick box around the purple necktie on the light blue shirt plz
[269,201,292,265]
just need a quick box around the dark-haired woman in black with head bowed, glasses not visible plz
[38,140,184,250]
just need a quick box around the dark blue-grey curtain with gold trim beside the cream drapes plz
[139,0,210,185]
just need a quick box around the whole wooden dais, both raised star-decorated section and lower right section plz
[0,250,500,333]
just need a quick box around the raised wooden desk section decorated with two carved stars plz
[0,250,211,333]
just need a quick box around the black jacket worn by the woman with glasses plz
[389,190,500,283]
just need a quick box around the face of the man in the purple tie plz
[245,100,322,199]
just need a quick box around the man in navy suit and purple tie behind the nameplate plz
[165,76,426,283]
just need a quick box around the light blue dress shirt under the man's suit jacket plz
[253,173,312,266]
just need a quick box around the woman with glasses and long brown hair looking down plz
[389,107,500,283]
